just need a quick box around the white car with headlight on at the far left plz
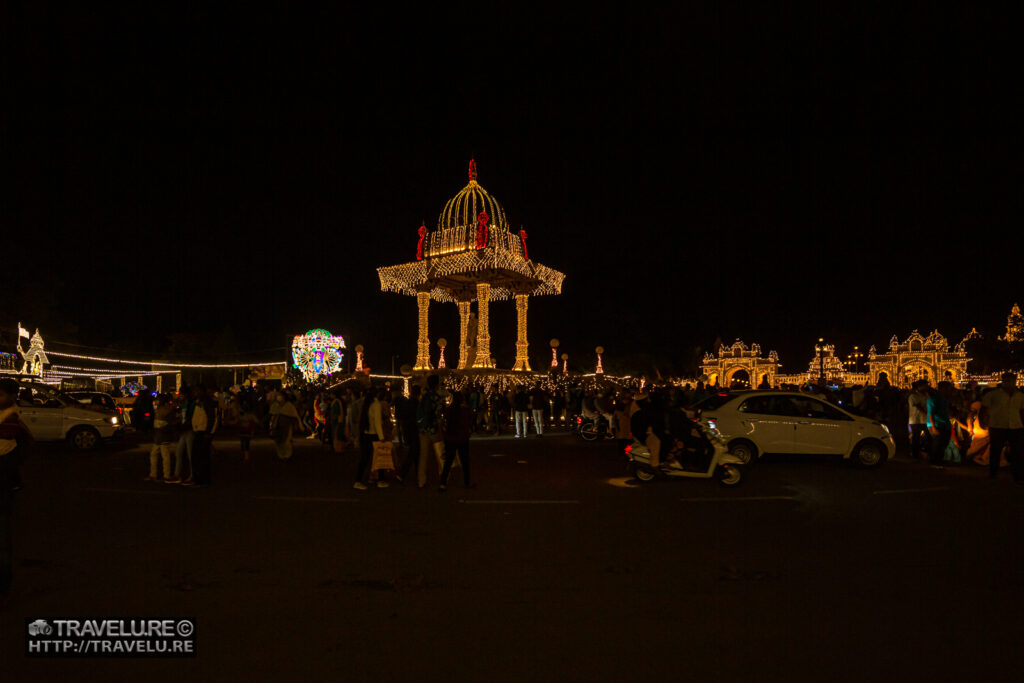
[17,381,122,451]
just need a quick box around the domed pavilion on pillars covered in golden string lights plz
[377,161,565,372]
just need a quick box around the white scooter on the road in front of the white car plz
[626,422,743,486]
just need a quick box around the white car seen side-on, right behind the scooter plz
[694,391,896,467]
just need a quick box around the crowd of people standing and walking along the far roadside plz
[125,375,1024,492]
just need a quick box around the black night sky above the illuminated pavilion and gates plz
[0,3,1024,371]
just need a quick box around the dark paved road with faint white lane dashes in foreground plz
[0,435,1024,681]
